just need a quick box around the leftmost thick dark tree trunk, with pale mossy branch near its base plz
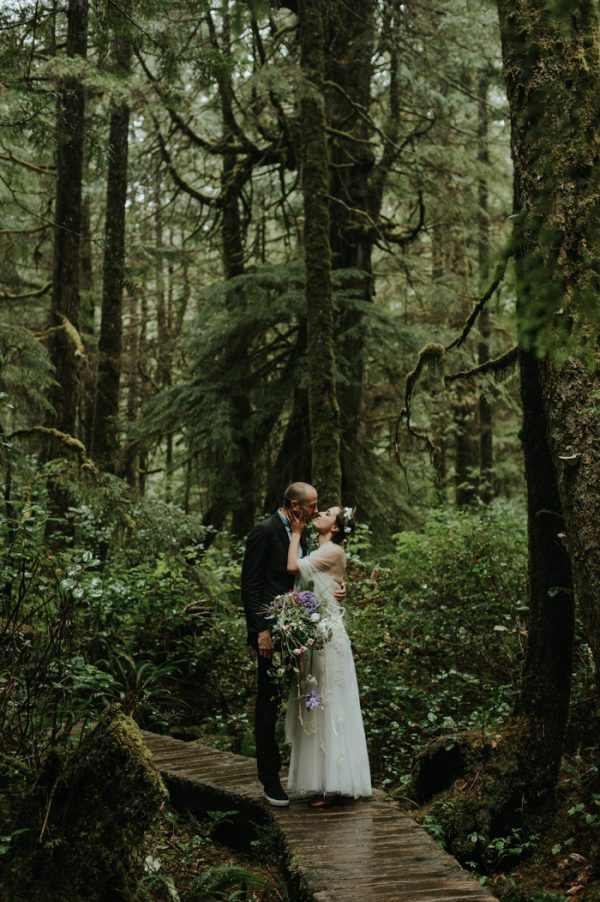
[49,0,88,442]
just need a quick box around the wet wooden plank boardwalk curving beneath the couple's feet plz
[144,733,494,902]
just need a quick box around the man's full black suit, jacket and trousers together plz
[242,512,305,785]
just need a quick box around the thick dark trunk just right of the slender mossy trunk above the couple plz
[325,0,378,501]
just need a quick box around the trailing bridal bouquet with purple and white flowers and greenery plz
[265,590,331,710]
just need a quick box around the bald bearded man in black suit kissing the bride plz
[242,482,317,807]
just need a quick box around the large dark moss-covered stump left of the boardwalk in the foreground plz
[5,711,167,902]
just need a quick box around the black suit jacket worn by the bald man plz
[242,511,306,645]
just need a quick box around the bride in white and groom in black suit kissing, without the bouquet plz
[242,482,372,808]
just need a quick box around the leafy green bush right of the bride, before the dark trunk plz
[346,502,527,787]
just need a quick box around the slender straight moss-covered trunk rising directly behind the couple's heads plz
[298,0,341,504]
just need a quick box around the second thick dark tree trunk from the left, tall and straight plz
[90,0,131,473]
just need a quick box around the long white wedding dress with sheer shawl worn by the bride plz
[285,541,372,799]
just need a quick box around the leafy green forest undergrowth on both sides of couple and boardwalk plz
[0,449,600,902]
